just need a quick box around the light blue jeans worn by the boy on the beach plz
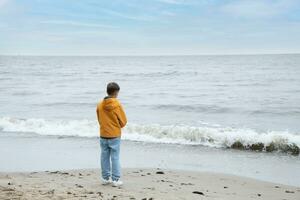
[100,137,121,181]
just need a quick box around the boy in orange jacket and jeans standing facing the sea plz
[96,82,127,187]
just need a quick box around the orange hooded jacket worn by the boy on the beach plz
[96,98,127,138]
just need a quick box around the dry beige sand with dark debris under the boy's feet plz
[0,169,300,200]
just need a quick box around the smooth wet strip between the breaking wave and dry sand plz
[0,137,300,186]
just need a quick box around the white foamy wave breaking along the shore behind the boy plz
[0,117,300,154]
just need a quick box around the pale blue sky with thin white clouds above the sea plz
[0,0,300,56]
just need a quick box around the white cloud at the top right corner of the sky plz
[221,0,295,18]
